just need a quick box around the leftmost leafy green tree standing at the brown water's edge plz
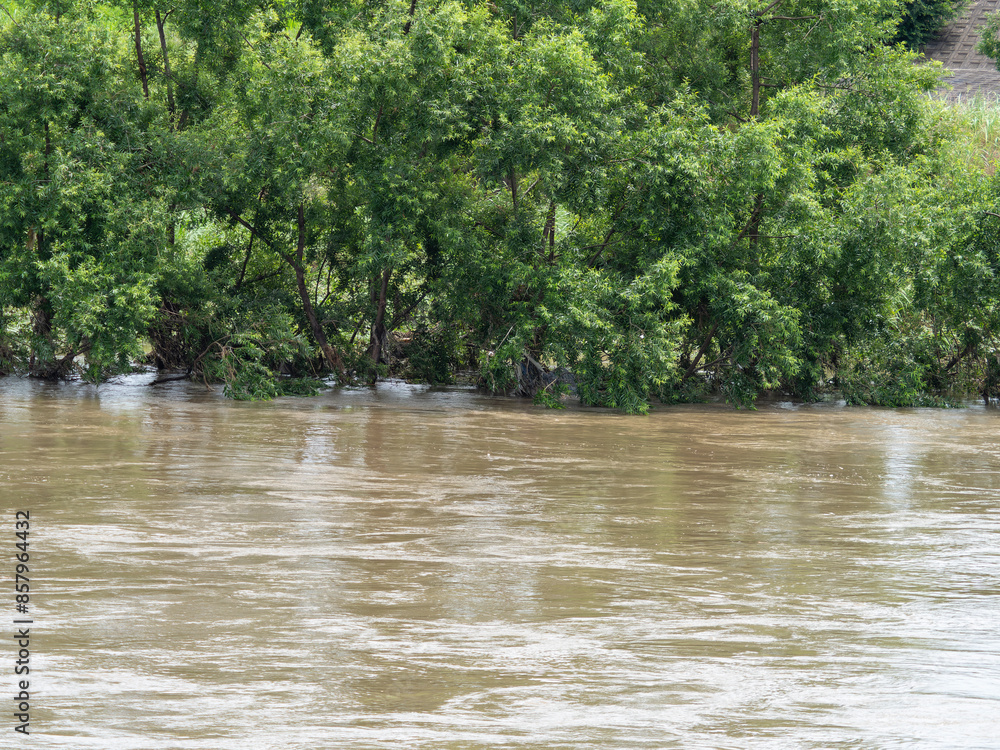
[0,7,163,378]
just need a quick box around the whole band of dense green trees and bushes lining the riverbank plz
[0,0,1000,412]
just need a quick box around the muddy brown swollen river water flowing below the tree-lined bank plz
[0,378,1000,750]
